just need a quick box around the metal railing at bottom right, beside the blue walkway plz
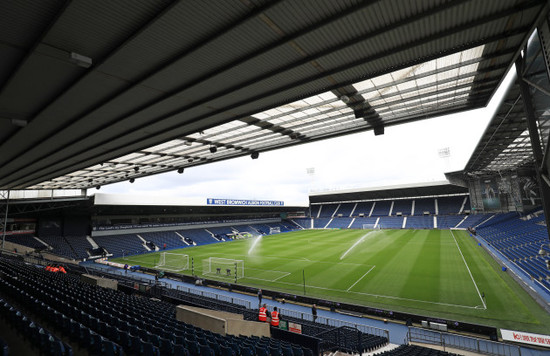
[407,327,521,356]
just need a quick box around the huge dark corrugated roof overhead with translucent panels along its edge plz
[0,0,547,189]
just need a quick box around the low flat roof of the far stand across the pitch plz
[309,181,468,203]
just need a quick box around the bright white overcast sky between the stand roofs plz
[95,71,514,204]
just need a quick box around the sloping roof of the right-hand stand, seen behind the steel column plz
[464,32,550,177]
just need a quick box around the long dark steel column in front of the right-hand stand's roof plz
[516,55,550,240]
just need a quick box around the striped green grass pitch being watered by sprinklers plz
[111,230,550,333]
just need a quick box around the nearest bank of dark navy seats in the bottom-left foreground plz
[0,257,320,355]
